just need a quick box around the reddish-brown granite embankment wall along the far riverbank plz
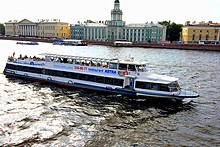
[0,37,220,51]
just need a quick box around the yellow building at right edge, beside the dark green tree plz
[181,21,220,43]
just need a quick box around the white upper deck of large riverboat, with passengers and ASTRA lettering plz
[8,53,178,84]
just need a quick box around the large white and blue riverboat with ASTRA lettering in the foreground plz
[4,53,199,100]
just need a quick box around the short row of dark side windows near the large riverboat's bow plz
[136,81,170,91]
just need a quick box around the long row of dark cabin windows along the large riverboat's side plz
[6,64,124,86]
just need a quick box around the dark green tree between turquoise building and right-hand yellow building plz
[159,21,183,43]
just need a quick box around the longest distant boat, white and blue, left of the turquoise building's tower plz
[53,39,87,46]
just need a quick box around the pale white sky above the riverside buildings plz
[0,0,220,24]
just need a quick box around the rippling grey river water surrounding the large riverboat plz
[0,40,220,147]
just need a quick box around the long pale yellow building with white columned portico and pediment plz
[5,19,70,38]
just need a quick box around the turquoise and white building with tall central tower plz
[70,0,166,42]
